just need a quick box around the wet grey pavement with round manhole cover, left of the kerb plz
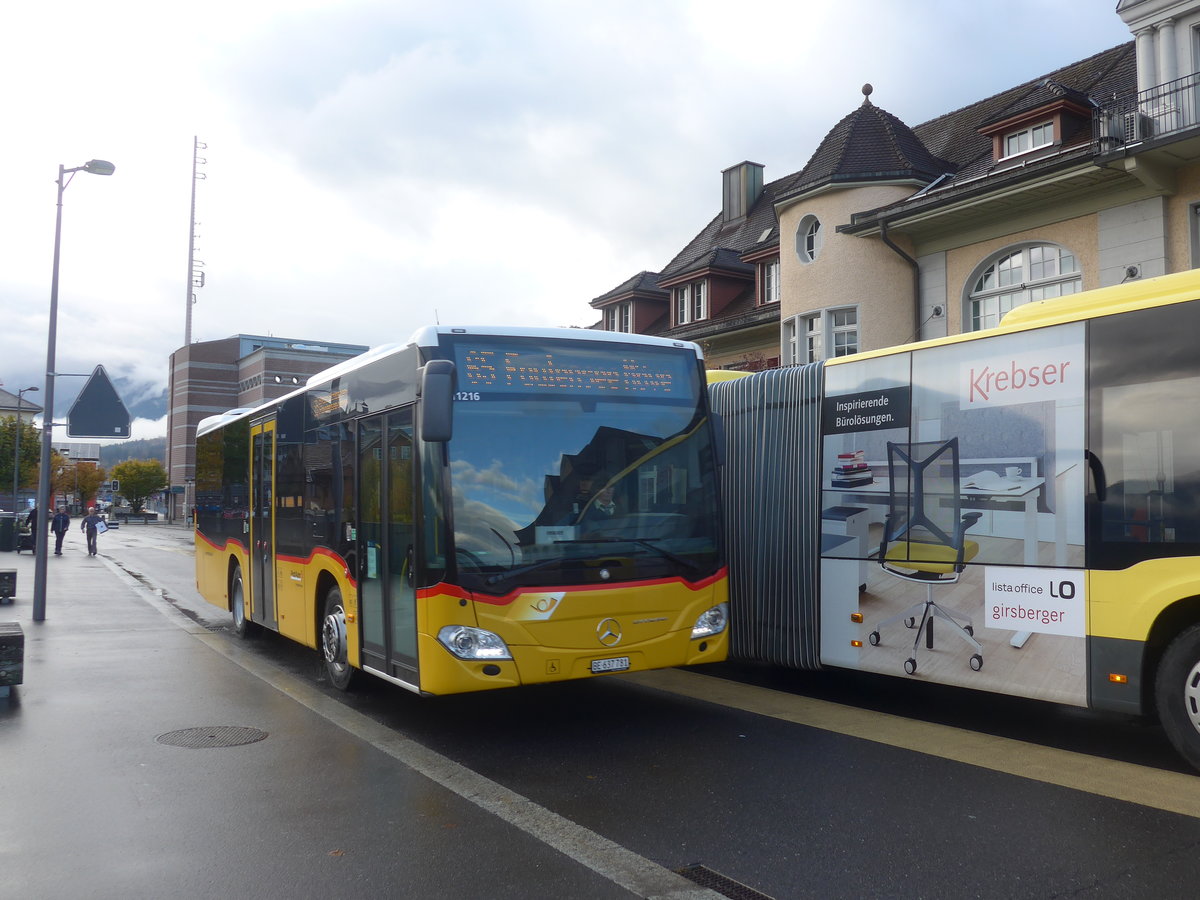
[0,548,696,900]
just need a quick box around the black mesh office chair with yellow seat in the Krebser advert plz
[868,438,983,674]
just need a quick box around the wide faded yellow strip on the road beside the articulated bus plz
[617,668,1200,818]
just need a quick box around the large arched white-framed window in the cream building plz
[967,244,1084,331]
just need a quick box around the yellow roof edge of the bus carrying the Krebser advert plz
[826,270,1200,366]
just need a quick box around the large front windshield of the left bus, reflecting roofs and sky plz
[448,354,718,594]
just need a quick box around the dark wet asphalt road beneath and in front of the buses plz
[58,526,1200,900]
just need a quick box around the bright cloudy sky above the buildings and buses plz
[0,0,1130,437]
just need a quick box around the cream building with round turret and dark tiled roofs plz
[592,0,1200,370]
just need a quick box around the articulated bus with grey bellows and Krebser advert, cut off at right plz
[709,272,1200,767]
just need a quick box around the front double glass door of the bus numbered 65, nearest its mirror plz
[358,407,419,686]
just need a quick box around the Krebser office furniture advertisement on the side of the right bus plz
[821,324,1087,706]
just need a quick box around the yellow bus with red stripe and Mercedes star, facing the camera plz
[196,326,728,694]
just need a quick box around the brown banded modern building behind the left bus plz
[167,335,370,518]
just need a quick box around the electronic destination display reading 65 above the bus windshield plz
[455,343,695,397]
